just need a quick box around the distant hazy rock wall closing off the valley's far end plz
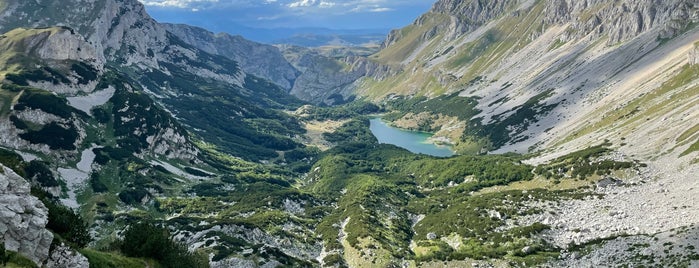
[163,24,392,105]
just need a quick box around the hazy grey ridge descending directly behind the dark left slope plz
[162,23,298,90]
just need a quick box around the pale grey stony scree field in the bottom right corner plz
[521,150,699,267]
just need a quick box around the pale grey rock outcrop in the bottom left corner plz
[0,165,53,265]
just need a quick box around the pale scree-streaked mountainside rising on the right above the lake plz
[356,0,699,267]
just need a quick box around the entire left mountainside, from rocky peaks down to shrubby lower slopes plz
[0,0,314,266]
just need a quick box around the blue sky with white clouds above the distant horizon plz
[140,0,434,34]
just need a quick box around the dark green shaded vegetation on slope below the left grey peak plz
[127,36,304,161]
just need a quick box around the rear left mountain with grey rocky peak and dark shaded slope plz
[1,1,308,161]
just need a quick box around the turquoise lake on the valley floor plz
[369,118,454,157]
